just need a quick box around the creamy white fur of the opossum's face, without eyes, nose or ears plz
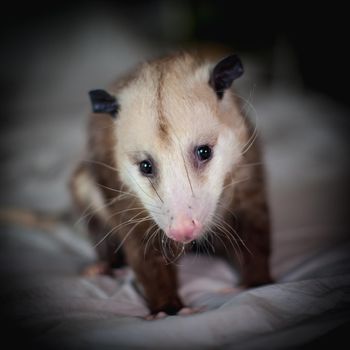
[115,57,245,241]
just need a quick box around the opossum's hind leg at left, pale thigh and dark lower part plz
[70,164,123,274]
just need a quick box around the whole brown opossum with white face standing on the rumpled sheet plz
[71,53,270,314]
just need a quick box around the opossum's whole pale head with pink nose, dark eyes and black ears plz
[90,54,247,243]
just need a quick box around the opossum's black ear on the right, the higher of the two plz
[209,55,244,99]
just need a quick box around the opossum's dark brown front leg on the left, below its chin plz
[124,239,184,315]
